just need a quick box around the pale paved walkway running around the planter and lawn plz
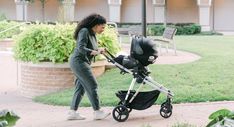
[0,46,234,127]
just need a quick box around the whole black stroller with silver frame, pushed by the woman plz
[104,36,174,122]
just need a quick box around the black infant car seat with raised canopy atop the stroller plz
[114,36,158,75]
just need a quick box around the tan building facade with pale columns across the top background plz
[0,0,234,31]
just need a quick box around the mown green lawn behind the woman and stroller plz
[34,36,234,106]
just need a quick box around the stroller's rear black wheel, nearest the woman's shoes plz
[112,105,129,122]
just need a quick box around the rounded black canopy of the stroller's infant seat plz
[130,36,158,66]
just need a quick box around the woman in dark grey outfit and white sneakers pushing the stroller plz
[68,14,110,120]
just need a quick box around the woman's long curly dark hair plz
[74,13,106,40]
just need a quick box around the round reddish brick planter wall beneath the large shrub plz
[20,61,105,98]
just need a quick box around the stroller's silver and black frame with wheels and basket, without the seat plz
[100,36,174,122]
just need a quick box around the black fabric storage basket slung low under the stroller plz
[116,90,160,110]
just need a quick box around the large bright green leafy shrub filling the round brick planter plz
[14,24,118,63]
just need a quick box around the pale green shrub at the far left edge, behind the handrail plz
[0,20,21,40]
